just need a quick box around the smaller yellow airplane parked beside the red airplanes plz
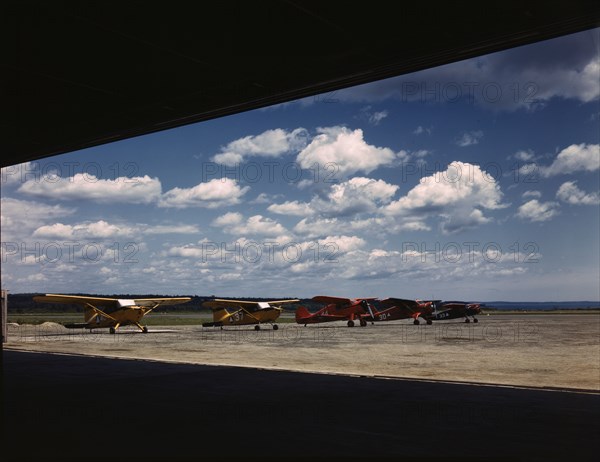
[202,298,300,330]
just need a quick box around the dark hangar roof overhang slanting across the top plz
[0,0,600,166]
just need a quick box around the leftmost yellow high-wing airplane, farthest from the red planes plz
[33,294,191,334]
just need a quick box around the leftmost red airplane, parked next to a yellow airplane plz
[296,295,376,327]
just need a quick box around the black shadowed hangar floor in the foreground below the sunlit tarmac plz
[2,350,600,462]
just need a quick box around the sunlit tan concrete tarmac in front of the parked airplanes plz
[5,314,600,392]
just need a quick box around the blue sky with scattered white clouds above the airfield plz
[2,29,600,301]
